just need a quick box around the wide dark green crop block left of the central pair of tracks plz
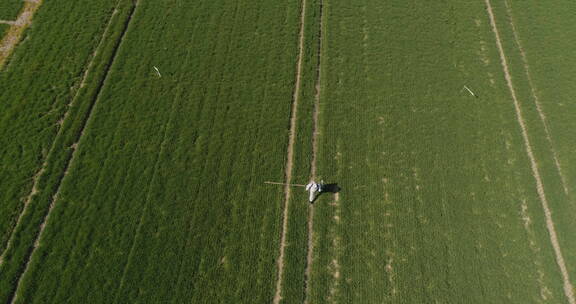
[7,0,299,303]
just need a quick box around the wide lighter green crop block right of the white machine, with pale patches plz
[311,0,564,303]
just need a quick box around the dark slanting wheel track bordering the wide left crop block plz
[9,0,138,304]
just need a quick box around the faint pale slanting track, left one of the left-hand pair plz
[0,1,120,265]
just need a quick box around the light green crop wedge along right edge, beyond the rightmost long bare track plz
[494,1,576,288]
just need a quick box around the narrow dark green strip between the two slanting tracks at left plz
[0,0,135,303]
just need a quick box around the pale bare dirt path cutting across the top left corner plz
[0,0,42,69]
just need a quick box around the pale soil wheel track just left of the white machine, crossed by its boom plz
[273,0,306,304]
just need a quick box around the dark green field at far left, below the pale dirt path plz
[0,1,123,299]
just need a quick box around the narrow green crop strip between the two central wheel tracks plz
[281,0,320,303]
